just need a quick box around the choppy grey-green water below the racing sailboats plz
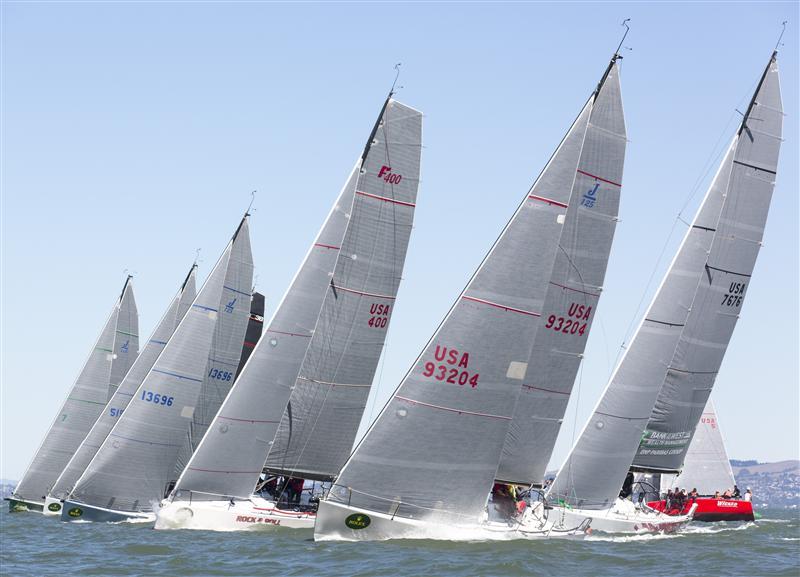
[0,503,800,577]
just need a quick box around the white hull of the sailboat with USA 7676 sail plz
[553,499,697,533]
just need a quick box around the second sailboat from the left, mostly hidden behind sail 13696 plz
[44,264,197,516]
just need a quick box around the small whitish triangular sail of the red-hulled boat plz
[661,397,735,495]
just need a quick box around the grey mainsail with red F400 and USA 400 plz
[267,98,422,479]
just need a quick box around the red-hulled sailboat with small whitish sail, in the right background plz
[648,397,755,522]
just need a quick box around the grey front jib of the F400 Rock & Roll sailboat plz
[173,159,361,498]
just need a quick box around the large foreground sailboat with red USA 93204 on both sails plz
[314,45,626,540]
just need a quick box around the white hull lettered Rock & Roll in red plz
[155,495,317,531]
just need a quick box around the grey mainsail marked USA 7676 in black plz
[633,54,783,473]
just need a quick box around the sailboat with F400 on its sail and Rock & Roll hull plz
[156,93,422,530]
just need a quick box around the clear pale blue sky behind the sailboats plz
[0,2,800,478]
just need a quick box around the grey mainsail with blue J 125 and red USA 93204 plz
[497,61,626,485]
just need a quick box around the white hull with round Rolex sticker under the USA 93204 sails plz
[314,501,586,541]
